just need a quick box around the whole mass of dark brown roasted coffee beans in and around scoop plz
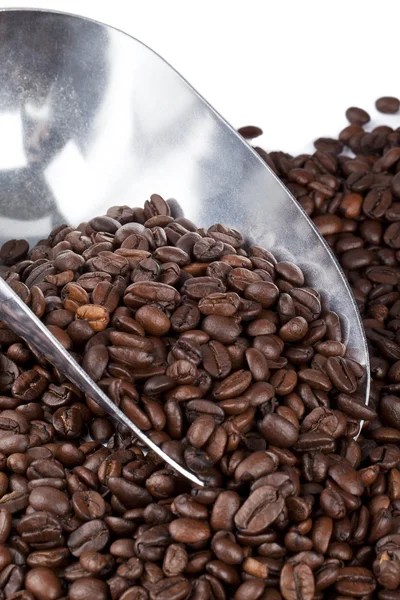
[0,98,400,600]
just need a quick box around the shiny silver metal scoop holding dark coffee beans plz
[0,10,370,485]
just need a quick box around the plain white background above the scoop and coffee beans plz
[0,0,400,153]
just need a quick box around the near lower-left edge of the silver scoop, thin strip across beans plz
[0,278,204,486]
